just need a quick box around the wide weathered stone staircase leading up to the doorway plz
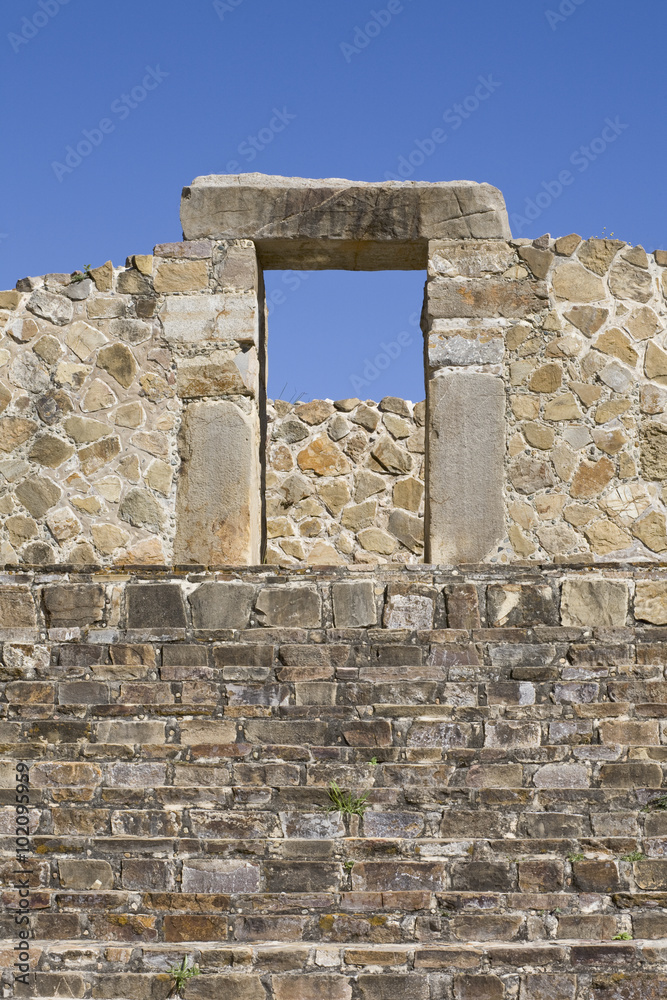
[0,567,667,1000]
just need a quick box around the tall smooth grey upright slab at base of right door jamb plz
[426,373,505,563]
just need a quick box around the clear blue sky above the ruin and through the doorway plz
[0,0,667,399]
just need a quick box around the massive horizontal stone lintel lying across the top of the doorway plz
[181,173,510,271]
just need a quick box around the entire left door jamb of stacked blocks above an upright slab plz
[155,240,263,566]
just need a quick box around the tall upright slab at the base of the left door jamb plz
[174,400,260,565]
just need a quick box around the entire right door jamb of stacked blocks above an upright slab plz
[422,240,544,565]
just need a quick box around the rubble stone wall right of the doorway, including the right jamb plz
[425,235,667,562]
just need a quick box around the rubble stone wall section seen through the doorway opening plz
[266,396,424,566]
